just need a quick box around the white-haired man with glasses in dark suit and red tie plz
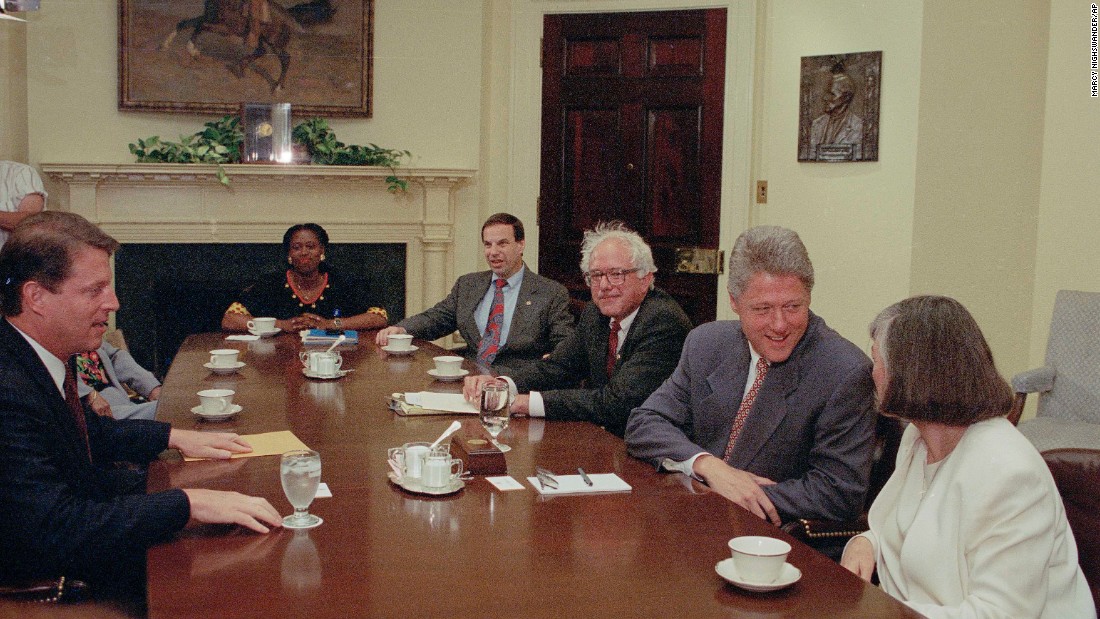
[463,222,691,436]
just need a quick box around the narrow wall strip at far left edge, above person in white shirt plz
[0,21,28,162]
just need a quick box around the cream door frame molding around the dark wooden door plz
[505,0,756,320]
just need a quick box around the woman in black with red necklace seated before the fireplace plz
[221,223,389,332]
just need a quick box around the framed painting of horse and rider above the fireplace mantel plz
[119,0,374,117]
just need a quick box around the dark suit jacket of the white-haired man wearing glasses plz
[510,289,691,436]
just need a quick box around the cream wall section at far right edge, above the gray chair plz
[1029,0,1100,367]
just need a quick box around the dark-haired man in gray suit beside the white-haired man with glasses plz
[375,213,573,373]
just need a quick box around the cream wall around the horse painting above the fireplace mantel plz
[25,0,483,290]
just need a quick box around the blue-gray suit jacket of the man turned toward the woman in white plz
[626,313,875,520]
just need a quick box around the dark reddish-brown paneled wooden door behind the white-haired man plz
[539,9,726,324]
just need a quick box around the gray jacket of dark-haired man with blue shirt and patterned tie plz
[397,265,573,374]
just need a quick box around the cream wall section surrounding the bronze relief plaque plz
[752,0,922,345]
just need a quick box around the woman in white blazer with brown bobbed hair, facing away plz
[842,297,1097,619]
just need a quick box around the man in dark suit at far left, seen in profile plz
[0,211,279,597]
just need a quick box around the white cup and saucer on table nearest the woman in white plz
[714,535,802,593]
